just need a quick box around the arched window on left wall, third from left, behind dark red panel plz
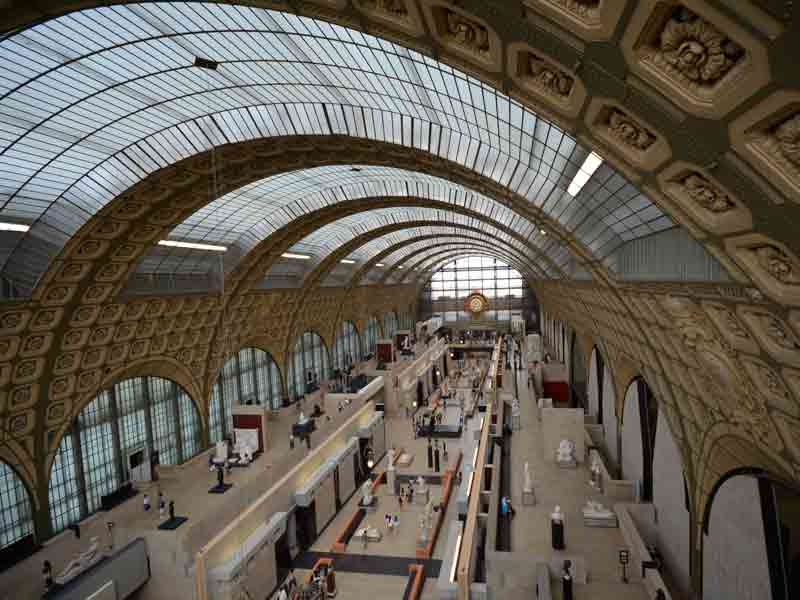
[208,348,283,443]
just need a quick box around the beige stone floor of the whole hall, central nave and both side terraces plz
[0,352,664,600]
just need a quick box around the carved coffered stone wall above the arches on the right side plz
[540,282,800,492]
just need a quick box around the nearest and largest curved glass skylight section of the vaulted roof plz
[0,2,671,285]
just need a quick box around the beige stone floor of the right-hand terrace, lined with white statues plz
[507,360,647,600]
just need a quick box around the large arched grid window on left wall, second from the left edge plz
[48,376,202,533]
